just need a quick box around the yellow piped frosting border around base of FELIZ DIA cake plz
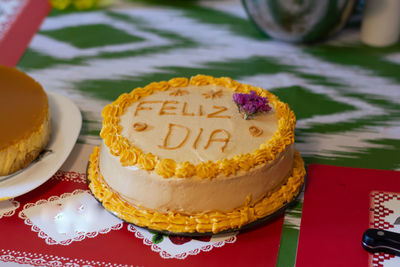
[87,147,306,233]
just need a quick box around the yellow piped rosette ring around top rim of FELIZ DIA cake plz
[100,75,296,178]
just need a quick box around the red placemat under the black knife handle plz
[296,165,400,267]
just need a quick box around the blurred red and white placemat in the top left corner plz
[0,0,51,66]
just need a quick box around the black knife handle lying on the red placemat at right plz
[362,229,400,256]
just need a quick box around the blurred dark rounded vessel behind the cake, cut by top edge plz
[242,0,357,43]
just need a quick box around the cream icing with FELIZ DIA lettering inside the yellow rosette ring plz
[120,85,278,164]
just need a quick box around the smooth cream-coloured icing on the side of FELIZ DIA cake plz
[100,142,294,214]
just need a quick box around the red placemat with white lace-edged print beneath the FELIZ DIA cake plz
[0,171,283,266]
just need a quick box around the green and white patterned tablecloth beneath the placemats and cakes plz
[17,0,400,266]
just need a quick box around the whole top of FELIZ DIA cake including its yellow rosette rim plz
[100,75,296,178]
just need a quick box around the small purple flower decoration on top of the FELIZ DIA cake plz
[233,91,271,120]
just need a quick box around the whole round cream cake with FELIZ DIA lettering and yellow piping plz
[88,75,305,233]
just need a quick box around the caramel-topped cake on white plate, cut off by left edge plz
[0,66,50,176]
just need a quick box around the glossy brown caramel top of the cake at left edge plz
[0,66,48,149]
